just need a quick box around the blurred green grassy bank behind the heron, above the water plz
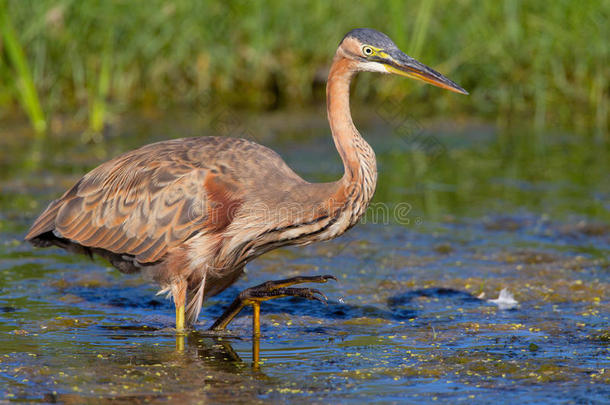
[0,0,610,140]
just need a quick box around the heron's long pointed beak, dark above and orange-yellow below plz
[381,50,468,94]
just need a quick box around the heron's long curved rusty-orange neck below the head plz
[326,53,377,205]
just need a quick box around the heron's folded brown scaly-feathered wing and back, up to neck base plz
[25,137,296,263]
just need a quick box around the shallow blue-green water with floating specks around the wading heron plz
[0,112,610,403]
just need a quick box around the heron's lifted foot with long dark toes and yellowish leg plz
[210,275,337,336]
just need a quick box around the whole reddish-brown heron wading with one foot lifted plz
[25,28,468,336]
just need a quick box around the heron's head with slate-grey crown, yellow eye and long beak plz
[337,28,468,94]
